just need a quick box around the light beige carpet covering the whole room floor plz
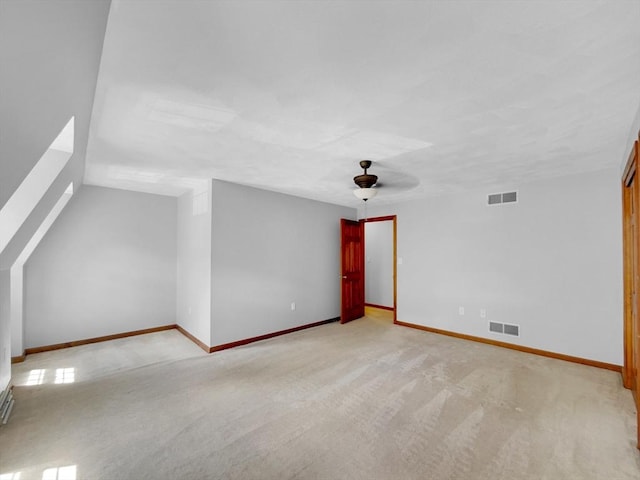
[0,316,640,480]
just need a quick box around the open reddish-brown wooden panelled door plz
[340,218,364,323]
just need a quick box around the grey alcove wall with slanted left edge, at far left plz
[24,186,177,348]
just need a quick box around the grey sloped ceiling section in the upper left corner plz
[0,0,110,208]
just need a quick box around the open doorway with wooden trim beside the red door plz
[363,215,397,322]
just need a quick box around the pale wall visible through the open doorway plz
[364,220,393,307]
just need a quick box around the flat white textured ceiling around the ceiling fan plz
[85,0,640,206]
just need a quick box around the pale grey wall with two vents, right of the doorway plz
[370,168,623,365]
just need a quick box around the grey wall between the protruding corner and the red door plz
[210,180,356,345]
